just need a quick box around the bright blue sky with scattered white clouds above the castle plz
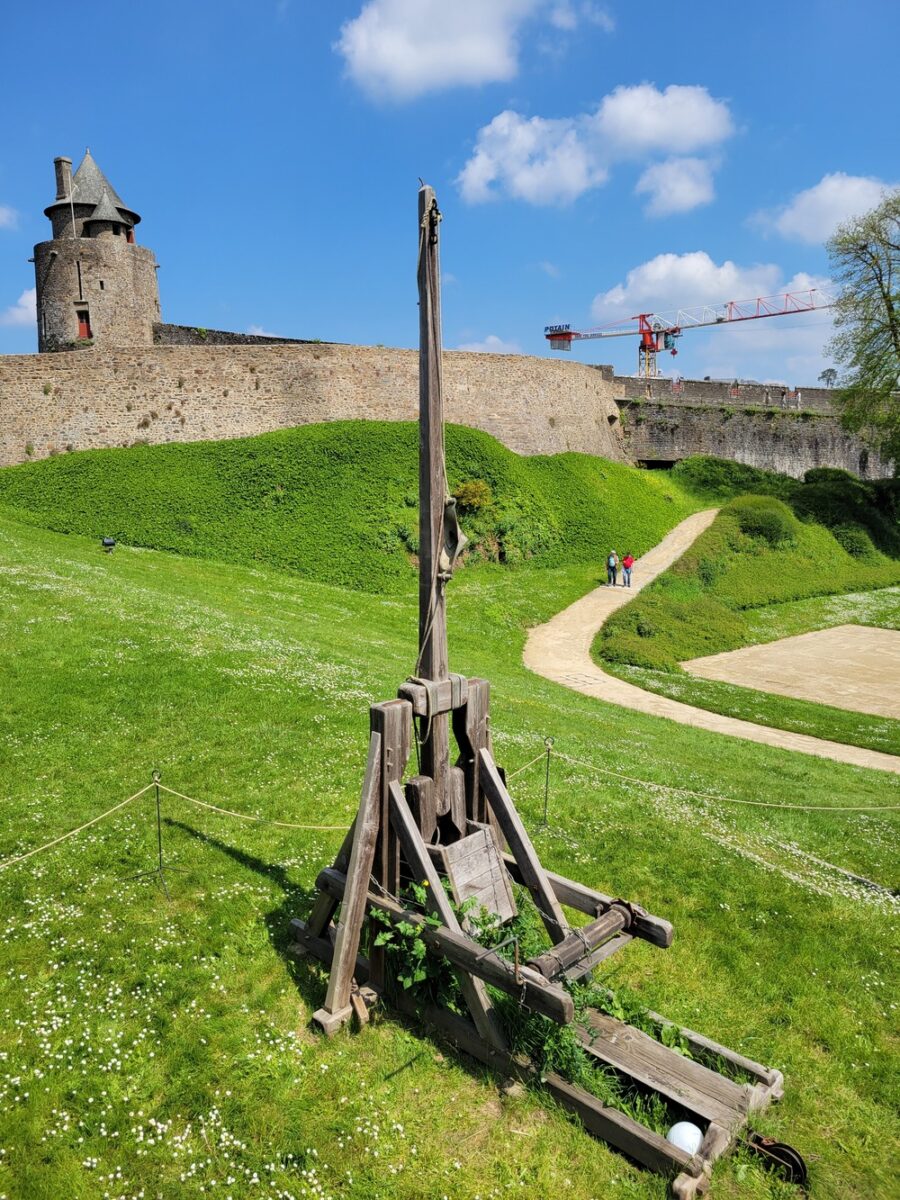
[0,0,900,385]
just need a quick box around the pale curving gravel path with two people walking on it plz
[524,509,900,774]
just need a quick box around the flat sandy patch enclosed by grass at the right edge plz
[682,625,900,719]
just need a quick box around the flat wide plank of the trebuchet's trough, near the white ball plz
[582,1009,749,1128]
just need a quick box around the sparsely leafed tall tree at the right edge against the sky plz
[828,190,900,463]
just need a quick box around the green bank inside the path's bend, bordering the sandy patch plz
[594,484,900,754]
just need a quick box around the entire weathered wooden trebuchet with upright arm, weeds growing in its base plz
[286,185,796,1200]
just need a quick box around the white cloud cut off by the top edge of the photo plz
[335,0,541,100]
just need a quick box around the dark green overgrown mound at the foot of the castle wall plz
[0,421,697,592]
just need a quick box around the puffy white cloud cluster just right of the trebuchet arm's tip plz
[456,84,733,206]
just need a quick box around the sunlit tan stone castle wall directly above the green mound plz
[0,343,626,466]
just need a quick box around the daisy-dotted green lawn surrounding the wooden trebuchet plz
[0,517,900,1200]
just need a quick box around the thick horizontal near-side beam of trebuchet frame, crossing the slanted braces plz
[316,868,575,1025]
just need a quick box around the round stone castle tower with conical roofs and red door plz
[35,150,161,353]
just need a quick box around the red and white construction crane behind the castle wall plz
[544,288,836,379]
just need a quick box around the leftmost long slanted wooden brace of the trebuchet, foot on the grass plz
[313,733,382,1030]
